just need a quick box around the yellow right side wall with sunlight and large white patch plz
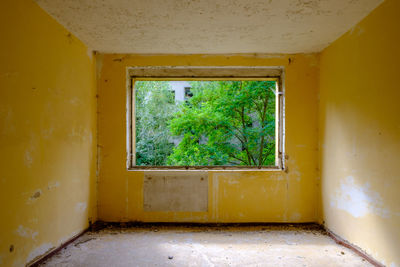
[319,0,400,266]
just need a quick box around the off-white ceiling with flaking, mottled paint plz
[35,0,383,54]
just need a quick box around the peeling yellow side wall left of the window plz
[0,0,96,266]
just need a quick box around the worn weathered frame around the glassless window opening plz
[127,73,285,171]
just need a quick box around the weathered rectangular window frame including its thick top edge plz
[126,66,285,171]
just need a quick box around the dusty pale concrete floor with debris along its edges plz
[41,226,372,267]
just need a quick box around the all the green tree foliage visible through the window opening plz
[136,81,275,166]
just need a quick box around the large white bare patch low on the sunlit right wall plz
[330,176,391,218]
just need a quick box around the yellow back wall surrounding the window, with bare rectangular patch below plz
[97,54,319,222]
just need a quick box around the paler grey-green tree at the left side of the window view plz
[135,81,177,166]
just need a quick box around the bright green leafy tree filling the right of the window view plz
[167,81,276,166]
